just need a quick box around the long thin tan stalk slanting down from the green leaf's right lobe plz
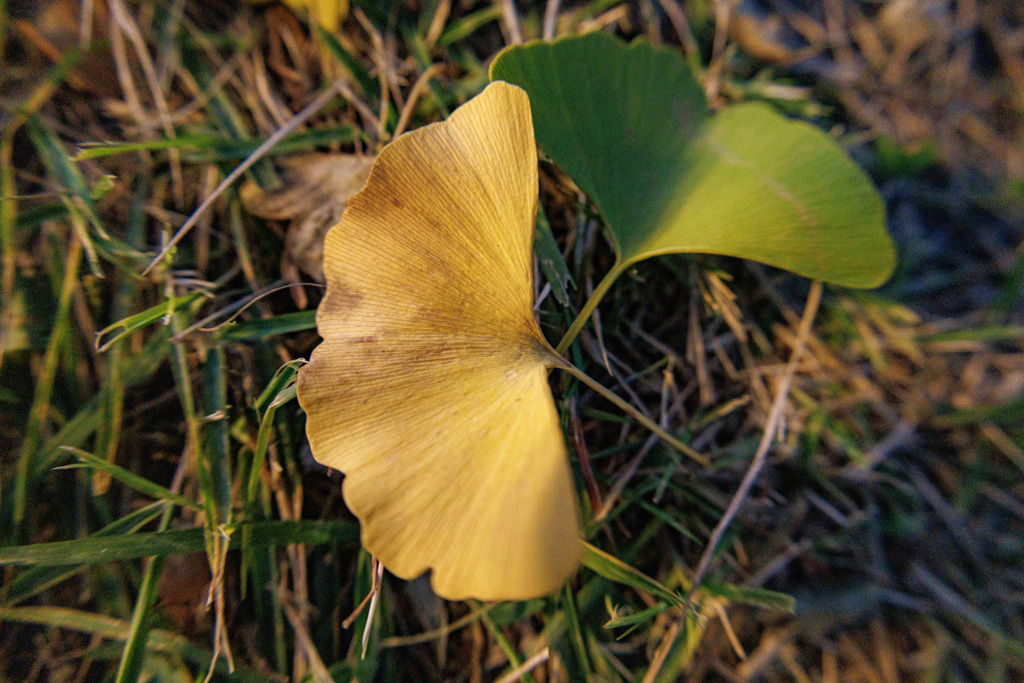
[688,281,821,600]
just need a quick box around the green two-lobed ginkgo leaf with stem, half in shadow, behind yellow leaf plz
[490,32,896,350]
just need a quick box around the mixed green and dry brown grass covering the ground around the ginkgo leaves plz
[0,0,1024,681]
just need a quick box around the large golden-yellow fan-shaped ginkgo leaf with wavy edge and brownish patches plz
[298,82,581,600]
